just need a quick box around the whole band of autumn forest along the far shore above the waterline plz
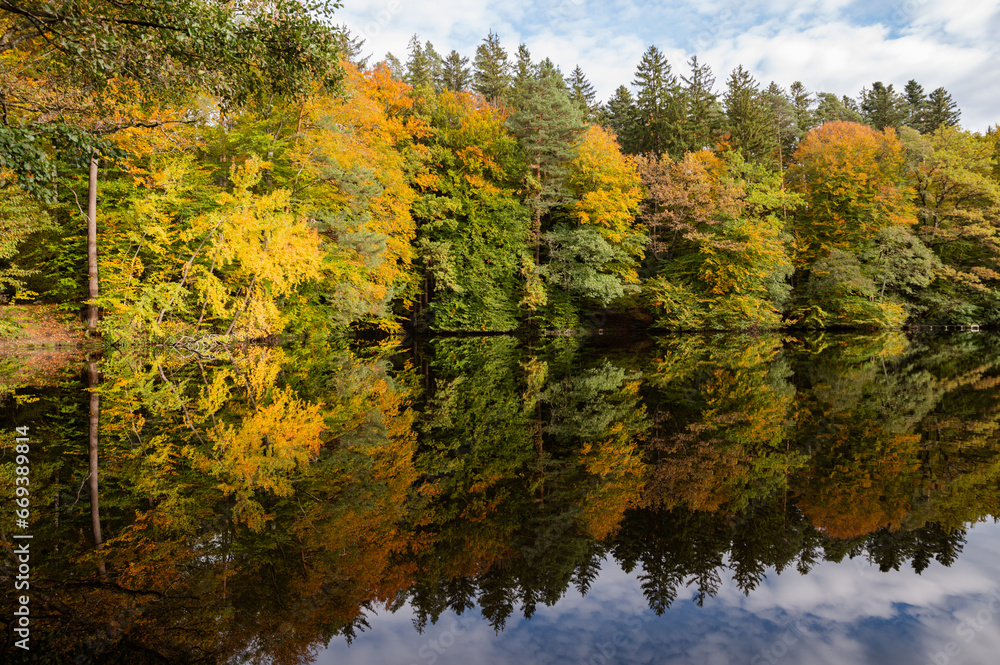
[0,0,1000,343]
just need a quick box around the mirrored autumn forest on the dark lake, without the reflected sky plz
[5,334,1000,663]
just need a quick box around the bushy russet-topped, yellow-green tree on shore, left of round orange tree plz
[640,151,799,329]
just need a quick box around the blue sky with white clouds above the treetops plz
[337,0,1000,131]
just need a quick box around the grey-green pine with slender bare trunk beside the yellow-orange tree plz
[507,76,585,264]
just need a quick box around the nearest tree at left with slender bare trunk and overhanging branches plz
[0,0,337,332]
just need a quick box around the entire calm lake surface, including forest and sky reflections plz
[0,333,1000,665]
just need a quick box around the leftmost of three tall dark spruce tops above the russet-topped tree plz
[632,46,681,157]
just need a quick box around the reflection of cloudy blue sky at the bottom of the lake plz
[316,523,1000,665]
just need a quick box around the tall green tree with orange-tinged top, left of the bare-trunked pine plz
[414,92,532,331]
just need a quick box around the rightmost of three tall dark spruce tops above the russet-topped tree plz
[723,65,778,162]
